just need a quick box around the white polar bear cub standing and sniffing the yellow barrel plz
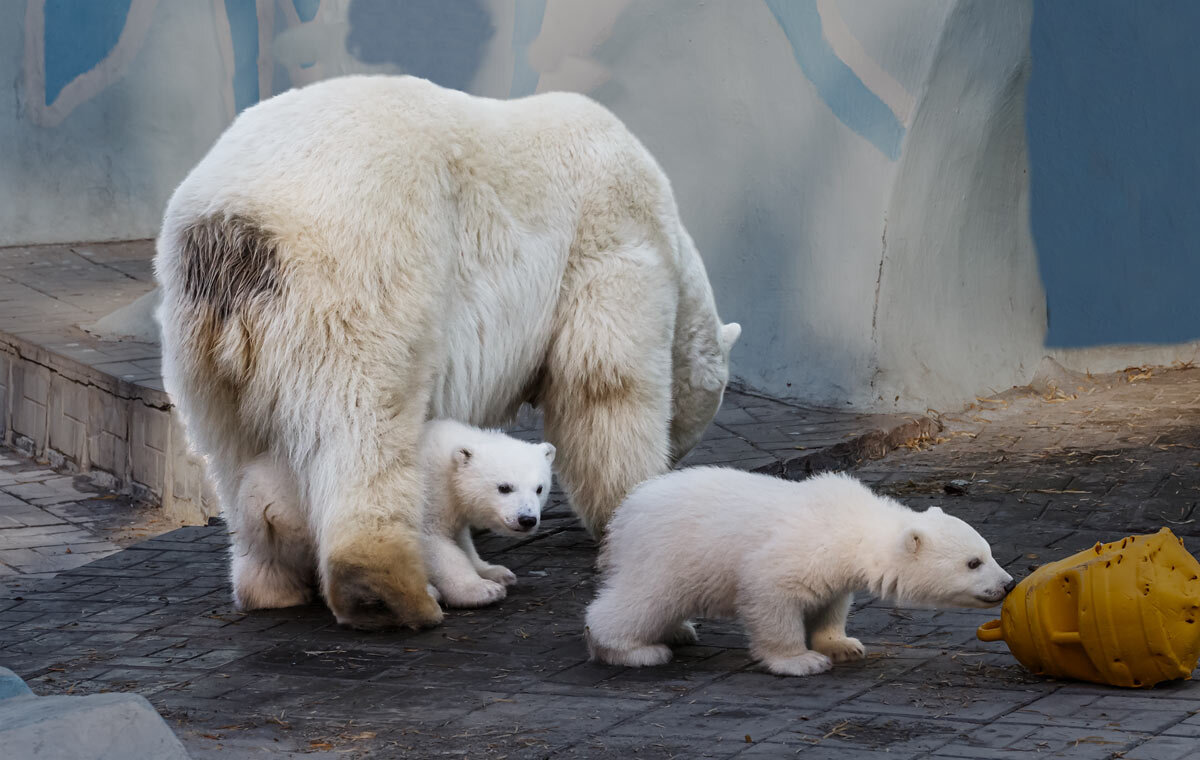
[586,467,1013,676]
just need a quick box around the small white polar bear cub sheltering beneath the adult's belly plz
[420,419,554,608]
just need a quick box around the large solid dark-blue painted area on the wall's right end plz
[1027,0,1200,347]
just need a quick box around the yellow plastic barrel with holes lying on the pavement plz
[977,528,1200,688]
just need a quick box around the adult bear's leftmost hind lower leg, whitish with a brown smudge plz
[226,455,317,610]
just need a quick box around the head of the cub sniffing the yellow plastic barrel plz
[895,507,1014,608]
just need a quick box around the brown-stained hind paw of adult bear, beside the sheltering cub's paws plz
[325,561,442,630]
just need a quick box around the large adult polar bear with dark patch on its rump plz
[155,77,739,628]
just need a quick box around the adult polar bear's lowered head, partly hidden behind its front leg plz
[671,318,742,466]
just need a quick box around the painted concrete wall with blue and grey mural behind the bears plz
[0,0,1200,409]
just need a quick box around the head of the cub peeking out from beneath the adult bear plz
[454,437,554,535]
